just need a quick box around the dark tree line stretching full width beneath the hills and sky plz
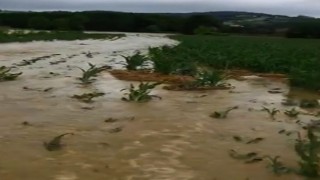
[0,11,320,38]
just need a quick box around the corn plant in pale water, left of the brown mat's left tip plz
[78,63,110,84]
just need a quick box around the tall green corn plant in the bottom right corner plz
[295,127,320,177]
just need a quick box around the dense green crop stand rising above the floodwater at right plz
[151,36,320,90]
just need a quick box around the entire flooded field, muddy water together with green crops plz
[0,32,320,180]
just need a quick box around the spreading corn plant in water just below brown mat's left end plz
[121,82,161,102]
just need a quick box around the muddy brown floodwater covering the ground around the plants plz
[0,34,319,180]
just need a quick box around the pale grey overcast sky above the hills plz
[0,0,320,17]
